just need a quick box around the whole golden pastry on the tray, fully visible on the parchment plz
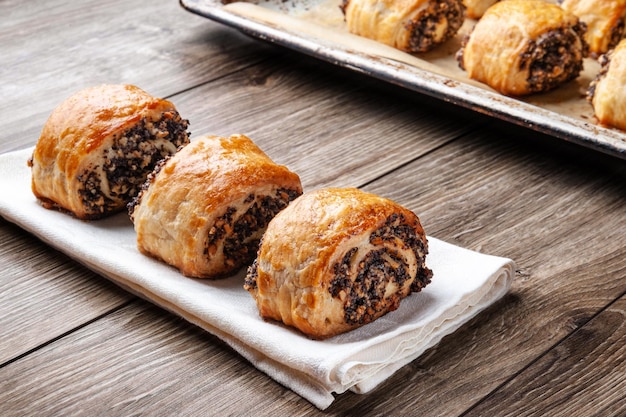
[457,0,588,96]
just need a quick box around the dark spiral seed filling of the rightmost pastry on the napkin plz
[328,214,432,325]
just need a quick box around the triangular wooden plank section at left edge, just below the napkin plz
[0,217,134,365]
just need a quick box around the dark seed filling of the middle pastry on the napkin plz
[204,188,300,268]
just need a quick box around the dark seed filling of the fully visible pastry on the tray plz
[520,22,589,92]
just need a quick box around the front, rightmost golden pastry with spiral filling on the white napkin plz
[244,188,432,339]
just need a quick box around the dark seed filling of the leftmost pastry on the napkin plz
[78,111,189,217]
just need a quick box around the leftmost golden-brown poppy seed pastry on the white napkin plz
[28,84,189,219]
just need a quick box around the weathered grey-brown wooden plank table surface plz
[0,0,626,416]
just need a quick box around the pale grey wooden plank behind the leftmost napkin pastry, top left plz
[0,0,273,151]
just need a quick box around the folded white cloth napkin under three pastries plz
[0,149,515,409]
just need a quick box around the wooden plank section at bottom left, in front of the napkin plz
[0,302,315,417]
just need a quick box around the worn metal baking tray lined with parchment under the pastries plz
[180,0,626,159]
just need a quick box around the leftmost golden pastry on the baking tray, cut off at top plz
[341,0,465,53]
